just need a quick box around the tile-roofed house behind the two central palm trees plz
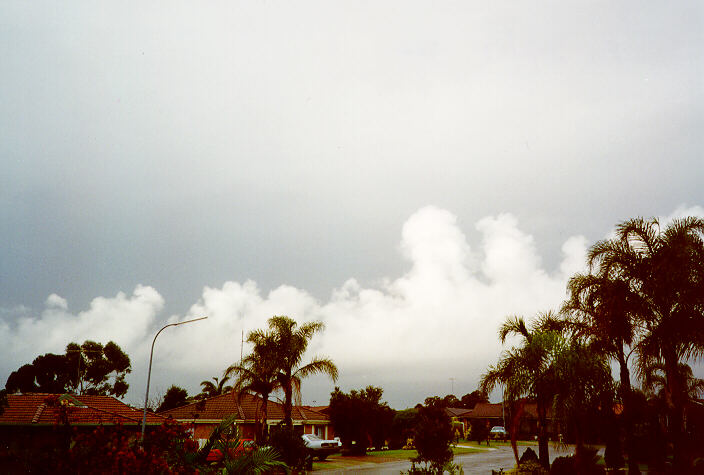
[159,393,334,445]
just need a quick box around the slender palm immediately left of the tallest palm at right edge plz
[562,274,641,473]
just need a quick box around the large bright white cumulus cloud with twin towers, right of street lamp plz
[143,207,586,406]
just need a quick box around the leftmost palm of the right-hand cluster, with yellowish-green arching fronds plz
[480,312,563,469]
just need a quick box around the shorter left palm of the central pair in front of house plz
[225,330,280,443]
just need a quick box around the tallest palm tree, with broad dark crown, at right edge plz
[589,217,704,469]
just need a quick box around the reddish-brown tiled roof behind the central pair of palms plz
[159,393,329,422]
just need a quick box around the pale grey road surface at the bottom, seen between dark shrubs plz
[313,446,588,475]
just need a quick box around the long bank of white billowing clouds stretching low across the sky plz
[0,206,704,407]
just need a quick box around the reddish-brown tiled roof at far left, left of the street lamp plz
[0,393,165,426]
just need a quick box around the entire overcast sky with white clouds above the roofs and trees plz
[0,0,704,408]
